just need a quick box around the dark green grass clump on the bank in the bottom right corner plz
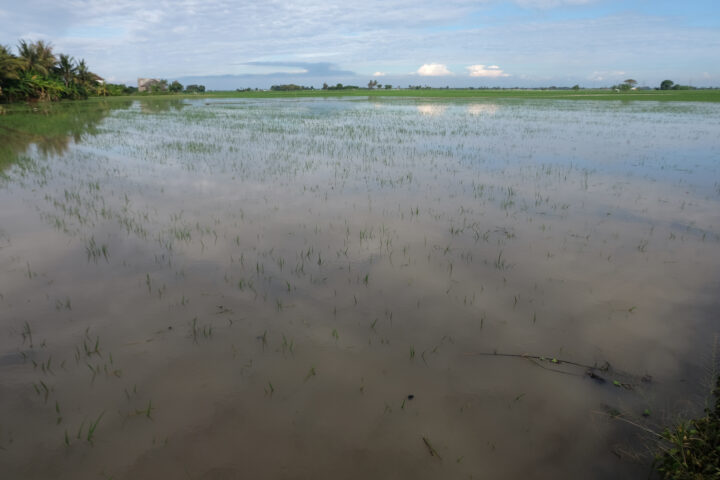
[655,377,720,480]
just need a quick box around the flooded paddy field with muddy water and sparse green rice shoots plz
[0,98,720,480]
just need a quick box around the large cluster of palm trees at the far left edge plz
[0,40,104,102]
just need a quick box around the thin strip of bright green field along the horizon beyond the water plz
[186,88,720,102]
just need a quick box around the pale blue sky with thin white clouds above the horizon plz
[0,0,720,90]
